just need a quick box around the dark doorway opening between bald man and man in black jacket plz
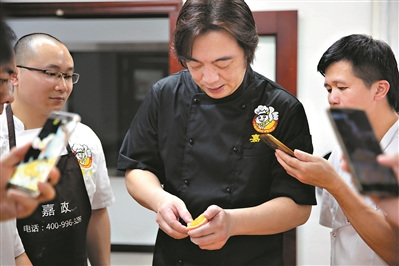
[68,51,169,175]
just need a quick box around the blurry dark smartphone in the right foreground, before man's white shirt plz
[328,108,399,197]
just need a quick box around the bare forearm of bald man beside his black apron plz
[86,208,111,266]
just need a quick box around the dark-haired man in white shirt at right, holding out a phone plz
[276,34,399,265]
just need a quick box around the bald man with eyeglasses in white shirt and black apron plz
[0,33,115,265]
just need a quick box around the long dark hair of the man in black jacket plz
[173,0,259,68]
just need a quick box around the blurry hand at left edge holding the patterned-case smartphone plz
[0,143,60,221]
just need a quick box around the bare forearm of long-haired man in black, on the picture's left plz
[125,169,168,212]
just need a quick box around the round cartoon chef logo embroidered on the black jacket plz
[252,105,278,133]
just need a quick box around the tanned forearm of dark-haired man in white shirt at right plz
[329,180,399,265]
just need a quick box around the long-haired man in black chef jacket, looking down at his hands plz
[118,0,316,265]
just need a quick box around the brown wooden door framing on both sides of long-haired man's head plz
[2,0,298,95]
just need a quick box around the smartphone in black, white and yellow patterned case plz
[8,111,80,197]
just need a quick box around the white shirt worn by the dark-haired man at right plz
[320,121,399,265]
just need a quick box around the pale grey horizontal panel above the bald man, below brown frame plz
[7,18,169,45]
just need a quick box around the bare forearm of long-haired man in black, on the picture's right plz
[227,197,312,235]
